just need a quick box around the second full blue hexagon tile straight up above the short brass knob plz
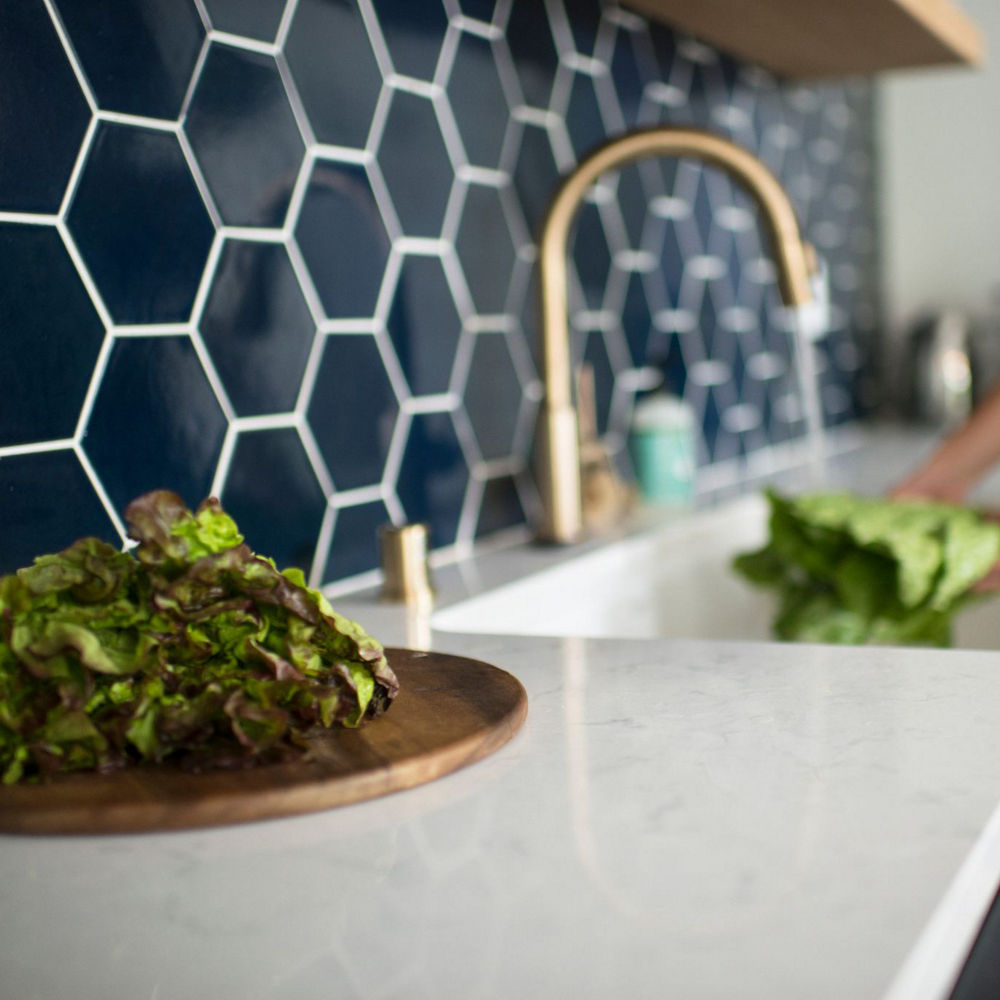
[387,256,462,396]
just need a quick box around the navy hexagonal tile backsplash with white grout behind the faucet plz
[0,0,878,584]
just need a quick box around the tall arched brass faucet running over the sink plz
[536,126,816,543]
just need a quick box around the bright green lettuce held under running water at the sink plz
[733,492,1000,646]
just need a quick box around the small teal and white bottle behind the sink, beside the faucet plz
[629,392,695,505]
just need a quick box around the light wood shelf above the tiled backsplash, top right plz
[625,0,985,79]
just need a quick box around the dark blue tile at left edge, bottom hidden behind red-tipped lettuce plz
[0,451,121,574]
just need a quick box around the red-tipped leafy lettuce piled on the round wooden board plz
[0,490,398,783]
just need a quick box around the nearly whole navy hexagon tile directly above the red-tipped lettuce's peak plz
[84,337,226,511]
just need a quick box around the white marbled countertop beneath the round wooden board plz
[0,424,1000,1000]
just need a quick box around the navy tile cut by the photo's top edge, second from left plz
[56,0,205,119]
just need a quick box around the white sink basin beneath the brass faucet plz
[431,495,1000,649]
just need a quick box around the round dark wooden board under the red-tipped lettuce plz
[0,649,528,833]
